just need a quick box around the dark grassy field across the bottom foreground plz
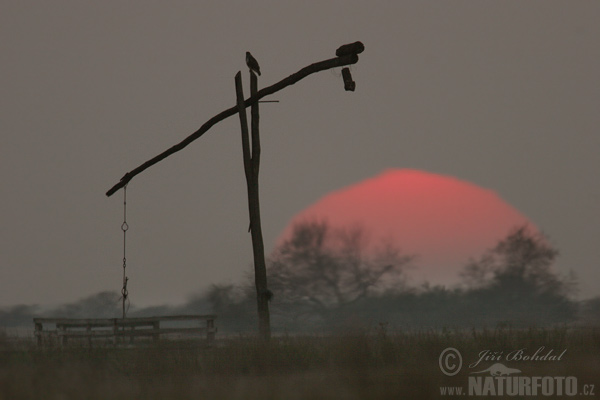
[0,325,600,400]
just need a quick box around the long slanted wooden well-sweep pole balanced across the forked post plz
[106,50,358,196]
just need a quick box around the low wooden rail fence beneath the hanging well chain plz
[33,315,217,346]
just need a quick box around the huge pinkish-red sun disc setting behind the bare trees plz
[281,169,535,284]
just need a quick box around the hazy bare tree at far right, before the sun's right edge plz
[463,226,576,326]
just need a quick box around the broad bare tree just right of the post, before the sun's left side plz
[269,221,412,326]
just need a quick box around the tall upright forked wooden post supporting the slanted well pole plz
[235,72,271,340]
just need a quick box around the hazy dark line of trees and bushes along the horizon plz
[0,221,600,333]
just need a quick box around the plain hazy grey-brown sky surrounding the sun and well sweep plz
[0,0,600,306]
